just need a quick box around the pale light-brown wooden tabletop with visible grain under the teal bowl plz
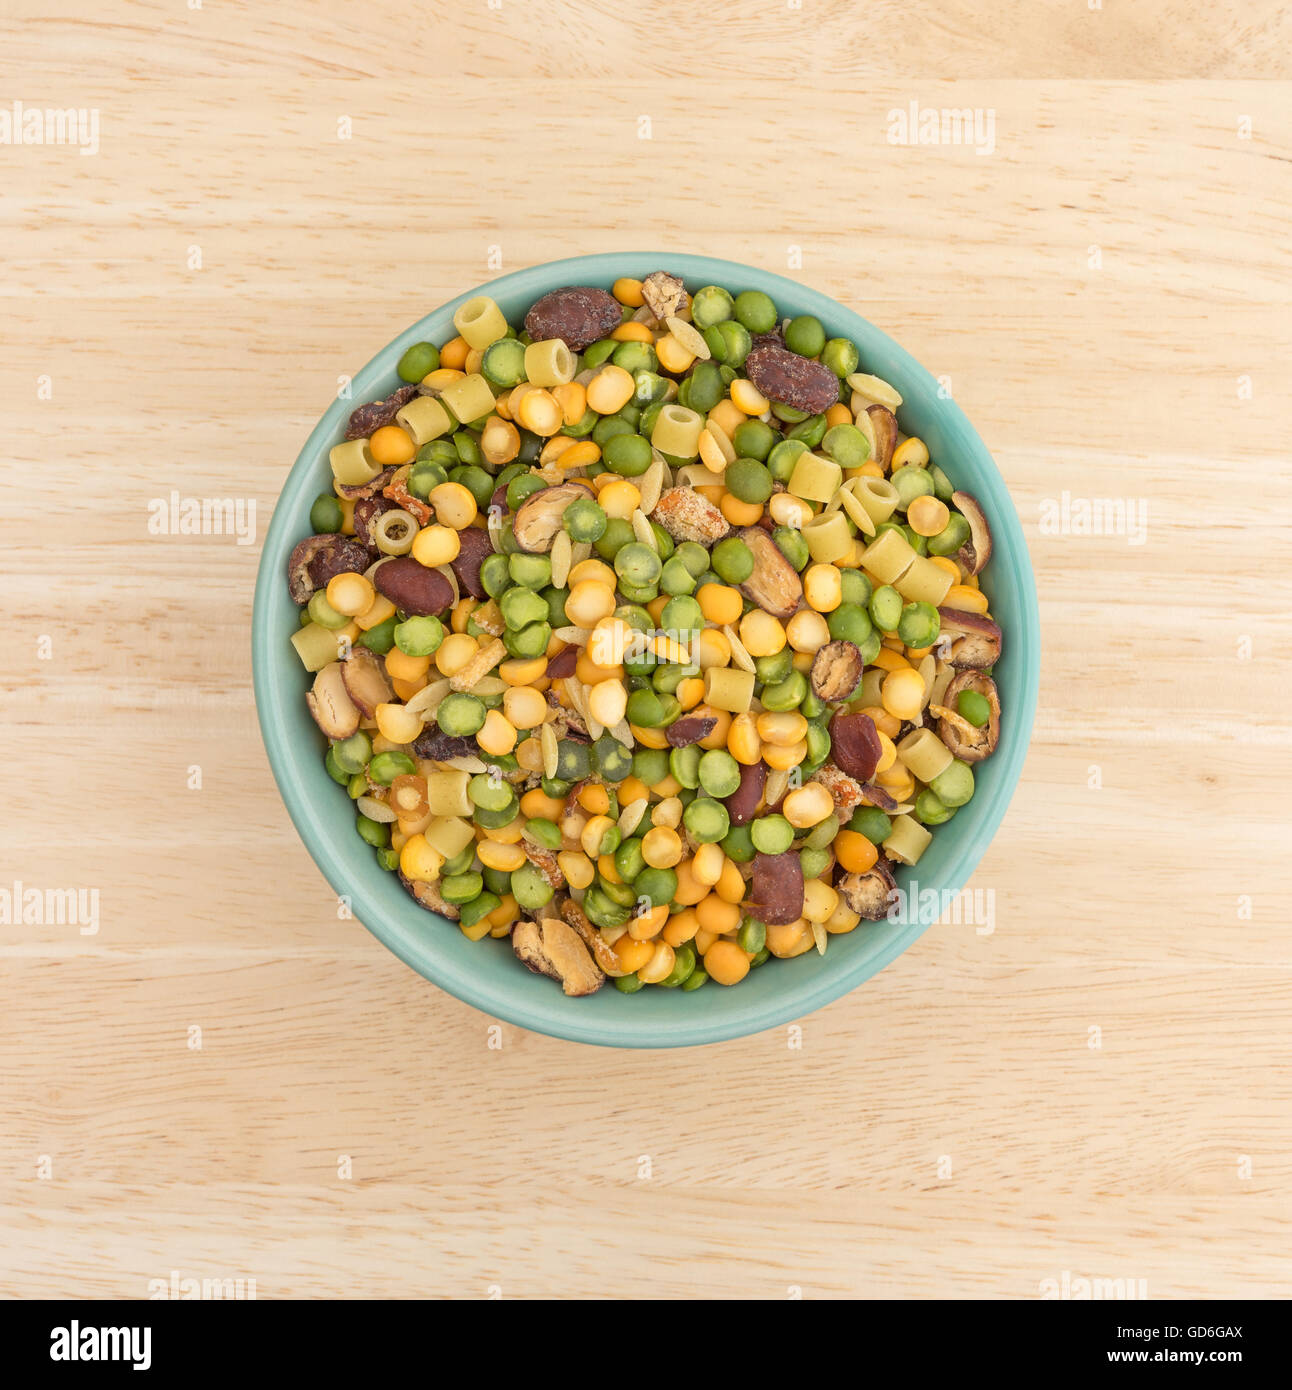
[0,0,1292,1298]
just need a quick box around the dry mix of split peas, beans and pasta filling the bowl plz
[288,270,1001,995]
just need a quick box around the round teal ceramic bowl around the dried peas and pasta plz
[252,252,1040,1048]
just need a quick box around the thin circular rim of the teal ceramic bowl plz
[250,250,1040,1048]
